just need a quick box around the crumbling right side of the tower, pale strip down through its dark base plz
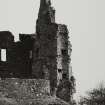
[56,24,72,102]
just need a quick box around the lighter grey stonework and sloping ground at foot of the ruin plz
[0,78,69,105]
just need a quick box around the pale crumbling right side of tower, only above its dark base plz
[57,24,70,84]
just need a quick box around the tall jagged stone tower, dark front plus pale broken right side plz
[32,0,70,100]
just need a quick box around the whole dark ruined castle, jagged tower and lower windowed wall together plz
[0,0,74,102]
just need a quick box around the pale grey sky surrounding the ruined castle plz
[0,0,105,101]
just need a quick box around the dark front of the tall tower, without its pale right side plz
[32,0,58,94]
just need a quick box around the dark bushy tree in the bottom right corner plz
[79,84,105,105]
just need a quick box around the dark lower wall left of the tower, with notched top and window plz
[0,31,35,78]
